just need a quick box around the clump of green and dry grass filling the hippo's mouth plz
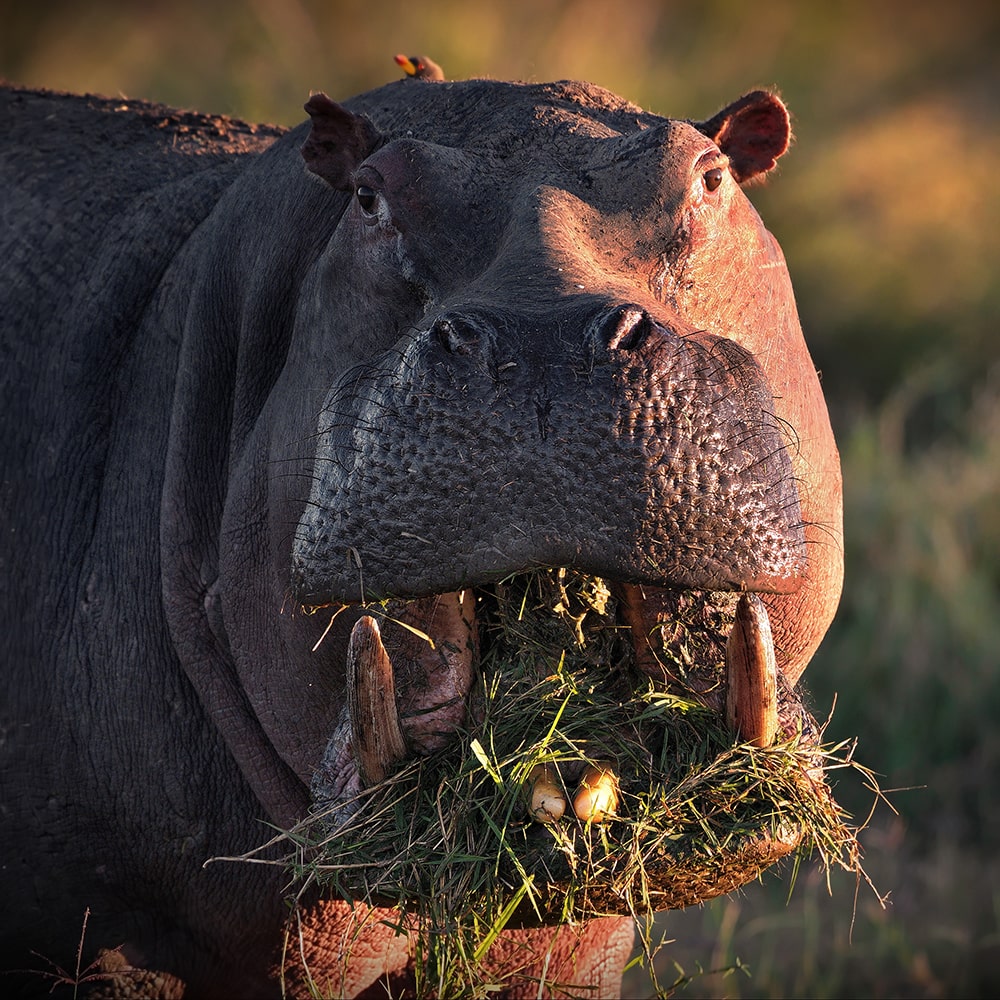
[266,571,860,994]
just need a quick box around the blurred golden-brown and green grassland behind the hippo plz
[0,0,1000,997]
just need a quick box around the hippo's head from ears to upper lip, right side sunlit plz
[276,81,842,812]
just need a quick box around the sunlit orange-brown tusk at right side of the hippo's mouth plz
[726,594,778,747]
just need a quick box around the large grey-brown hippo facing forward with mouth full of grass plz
[0,64,843,997]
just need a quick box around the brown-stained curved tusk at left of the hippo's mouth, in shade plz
[347,615,406,786]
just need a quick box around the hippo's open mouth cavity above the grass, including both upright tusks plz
[315,569,801,802]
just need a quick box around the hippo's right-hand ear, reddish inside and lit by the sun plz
[695,90,792,184]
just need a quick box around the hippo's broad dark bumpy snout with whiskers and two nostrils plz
[293,303,806,604]
